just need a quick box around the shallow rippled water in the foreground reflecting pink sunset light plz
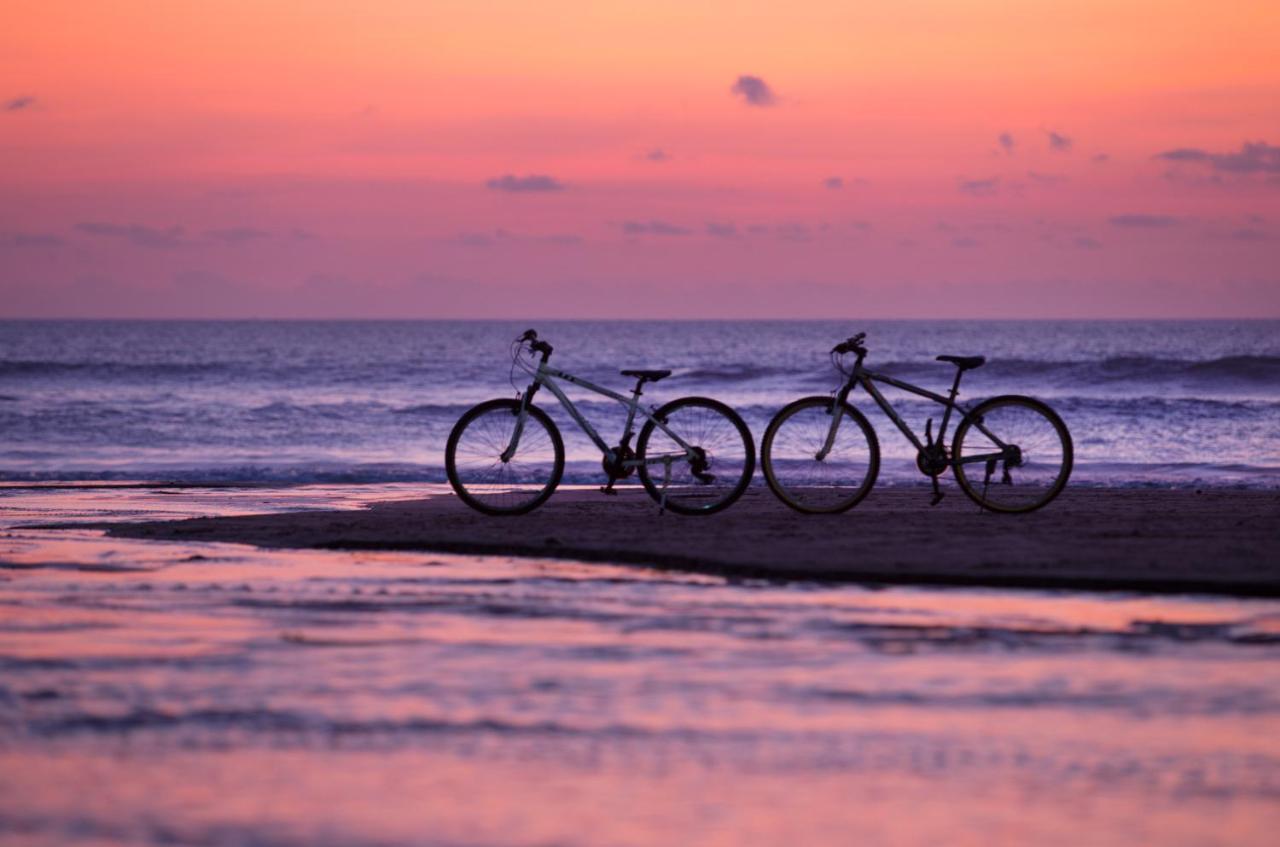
[0,486,1280,846]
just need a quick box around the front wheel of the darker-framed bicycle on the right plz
[760,397,879,514]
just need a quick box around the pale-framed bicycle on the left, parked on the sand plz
[444,330,755,514]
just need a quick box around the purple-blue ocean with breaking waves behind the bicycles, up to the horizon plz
[0,320,1280,487]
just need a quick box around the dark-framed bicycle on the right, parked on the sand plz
[760,333,1074,513]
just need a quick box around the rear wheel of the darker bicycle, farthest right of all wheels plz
[951,395,1074,513]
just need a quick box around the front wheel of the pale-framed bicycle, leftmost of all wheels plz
[444,399,564,514]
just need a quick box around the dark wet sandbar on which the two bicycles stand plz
[92,487,1280,596]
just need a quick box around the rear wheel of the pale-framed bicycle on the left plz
[636,397,755,514]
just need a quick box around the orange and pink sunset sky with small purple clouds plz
[0,0,1280,319]
